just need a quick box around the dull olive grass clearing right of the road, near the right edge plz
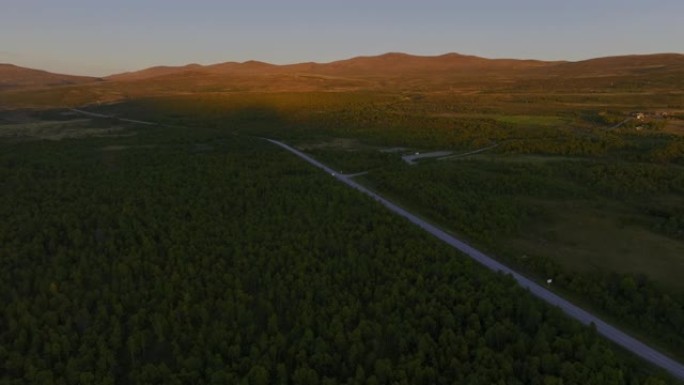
[507,201,684,292]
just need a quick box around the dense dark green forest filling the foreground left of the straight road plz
[0,118,673,385]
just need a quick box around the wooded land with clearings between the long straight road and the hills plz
[87,92,684,366]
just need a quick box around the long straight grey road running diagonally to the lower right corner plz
[264,138,684,379]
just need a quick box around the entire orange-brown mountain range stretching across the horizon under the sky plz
[0,53,684,93]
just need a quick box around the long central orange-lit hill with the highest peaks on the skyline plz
[96,53,557,93]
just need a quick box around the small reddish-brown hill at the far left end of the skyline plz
[0,63,98,91]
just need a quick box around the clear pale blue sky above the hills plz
[0,0,684,76]
